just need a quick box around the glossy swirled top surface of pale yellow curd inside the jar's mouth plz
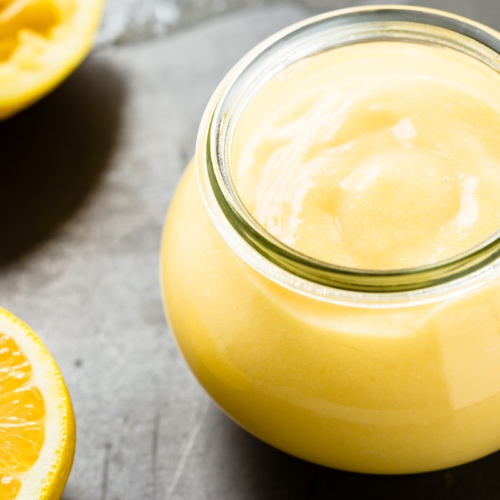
[233,42,500,269]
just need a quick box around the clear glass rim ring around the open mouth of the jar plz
[199,6,500,294]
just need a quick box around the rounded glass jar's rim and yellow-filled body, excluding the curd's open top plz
[161,6,500,474]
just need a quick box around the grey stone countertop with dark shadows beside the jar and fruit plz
[0,0,500,500]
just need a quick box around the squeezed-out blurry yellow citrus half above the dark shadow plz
[0,0,104,119]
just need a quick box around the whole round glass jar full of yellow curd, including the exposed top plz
[161,6,500,474]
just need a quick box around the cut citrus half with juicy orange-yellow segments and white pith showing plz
[0,308,76,500]
